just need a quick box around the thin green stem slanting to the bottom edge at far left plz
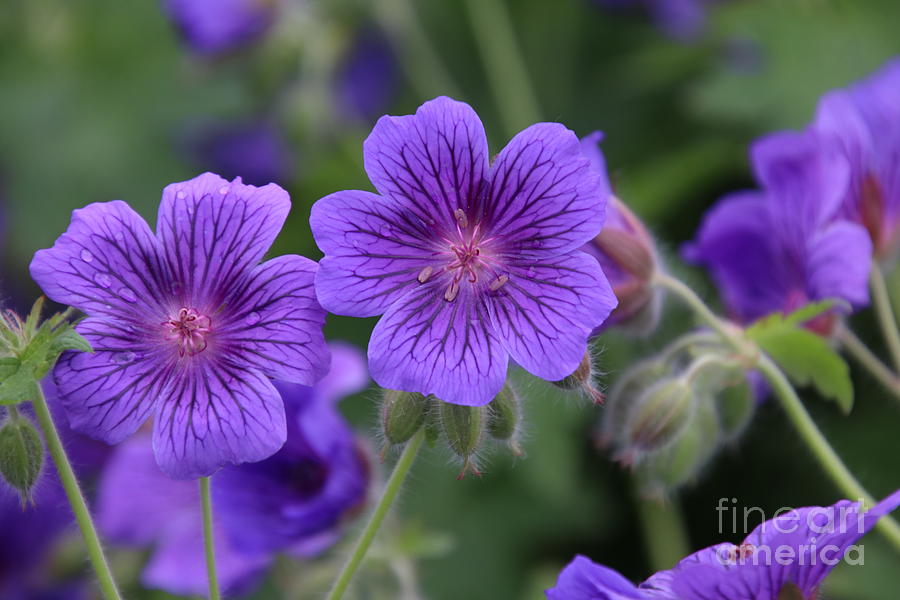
[32,384,120,600]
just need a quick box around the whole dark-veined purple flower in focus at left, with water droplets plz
[31,173,328,478]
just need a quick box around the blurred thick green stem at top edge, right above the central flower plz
[466,0,541,135]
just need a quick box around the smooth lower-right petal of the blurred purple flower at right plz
[808,222,872,307]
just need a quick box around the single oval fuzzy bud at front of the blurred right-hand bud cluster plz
[625,377,694,452]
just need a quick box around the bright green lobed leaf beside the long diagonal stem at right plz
[747,302,853,414]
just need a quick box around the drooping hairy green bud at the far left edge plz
[0,415,44,503]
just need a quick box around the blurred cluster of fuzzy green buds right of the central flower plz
[597,338,755,495]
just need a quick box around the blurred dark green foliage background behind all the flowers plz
[0,0,900,600]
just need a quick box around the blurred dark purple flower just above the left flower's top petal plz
[187,121,294,186]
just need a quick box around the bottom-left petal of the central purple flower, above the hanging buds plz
[369,279,507,406]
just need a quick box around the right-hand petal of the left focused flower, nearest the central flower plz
[218,255,329,385]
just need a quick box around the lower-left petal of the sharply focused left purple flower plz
[53,317,171,444]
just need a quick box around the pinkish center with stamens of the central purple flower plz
[416,208,509,302]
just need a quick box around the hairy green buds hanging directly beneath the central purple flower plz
[381,382,522,478]
